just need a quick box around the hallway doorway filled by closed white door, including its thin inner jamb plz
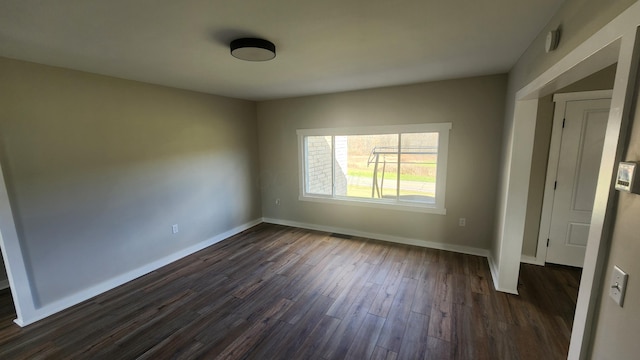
[537,90,612,268]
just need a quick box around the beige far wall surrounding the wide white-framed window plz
[258,75,506,250]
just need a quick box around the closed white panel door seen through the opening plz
[546,99,611,267]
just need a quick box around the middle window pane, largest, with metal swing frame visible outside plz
[336,134,398,199]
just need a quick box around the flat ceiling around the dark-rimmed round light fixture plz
[0,0,563,100]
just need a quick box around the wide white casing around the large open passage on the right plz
[496,1,640,359]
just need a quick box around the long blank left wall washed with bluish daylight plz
[0,58,261,306]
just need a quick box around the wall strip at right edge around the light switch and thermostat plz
[592,61,640,359]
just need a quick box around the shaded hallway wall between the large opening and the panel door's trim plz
[522,64,616,257]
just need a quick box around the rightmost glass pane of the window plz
[400,133,438,204]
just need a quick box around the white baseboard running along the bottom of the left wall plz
[14,219,262,327]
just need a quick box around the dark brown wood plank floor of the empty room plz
[0,224,580,360]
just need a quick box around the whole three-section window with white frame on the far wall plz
[297,123,451,214]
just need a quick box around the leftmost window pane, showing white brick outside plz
[304,136,333,195]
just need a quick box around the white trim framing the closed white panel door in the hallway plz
[535,90,613,265]
